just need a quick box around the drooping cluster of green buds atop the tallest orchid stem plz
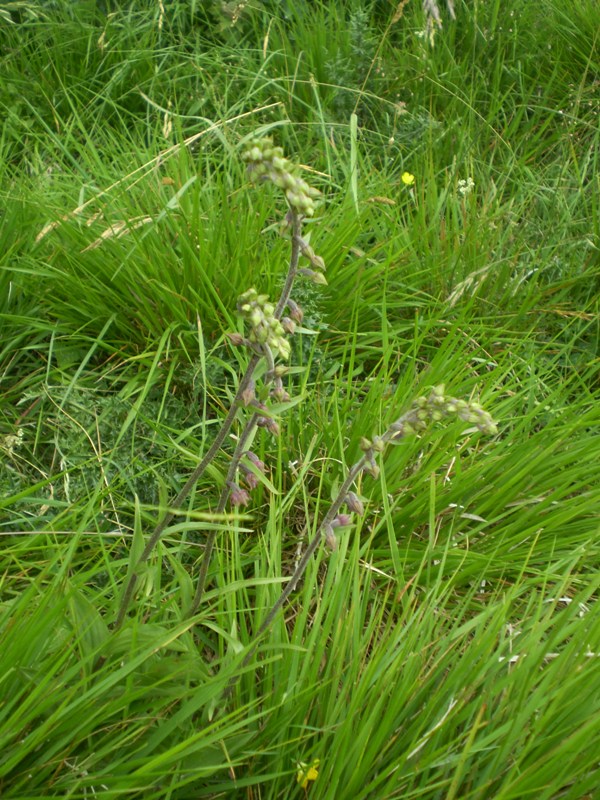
[242,138,321,217]
